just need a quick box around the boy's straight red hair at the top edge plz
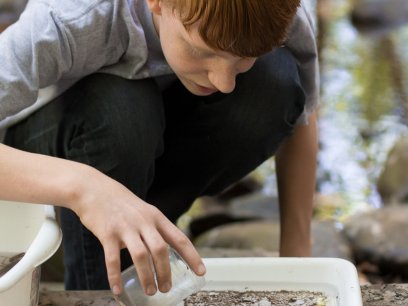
[169,0,300,57]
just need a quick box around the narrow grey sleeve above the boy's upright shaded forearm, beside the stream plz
[285,3,320,124]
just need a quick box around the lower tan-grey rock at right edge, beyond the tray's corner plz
[343,205,408,278]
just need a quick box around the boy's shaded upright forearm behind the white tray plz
[275,114,317,256]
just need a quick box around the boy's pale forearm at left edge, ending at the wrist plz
[0,144,89,209]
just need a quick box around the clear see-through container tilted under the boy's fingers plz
[116,248,205,306]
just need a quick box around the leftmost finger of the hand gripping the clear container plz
[104,244,122,295]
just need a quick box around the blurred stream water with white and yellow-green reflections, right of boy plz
[260,0,408,220]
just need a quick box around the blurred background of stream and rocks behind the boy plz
[0,0,408,290]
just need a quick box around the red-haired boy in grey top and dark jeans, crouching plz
[0,0,317,295]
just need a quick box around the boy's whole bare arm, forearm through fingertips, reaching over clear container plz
[0,143,205,294]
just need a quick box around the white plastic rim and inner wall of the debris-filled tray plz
[203,257,363,306]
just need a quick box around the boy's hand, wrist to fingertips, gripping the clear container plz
[70,169,205,295]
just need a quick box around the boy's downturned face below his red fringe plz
[149,0,256,96]
